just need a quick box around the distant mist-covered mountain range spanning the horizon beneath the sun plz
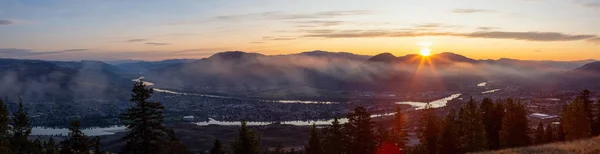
[0,51,600,100]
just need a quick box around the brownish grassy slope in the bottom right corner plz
[474,137,600,154]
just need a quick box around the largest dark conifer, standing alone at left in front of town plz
[121,81,182,154]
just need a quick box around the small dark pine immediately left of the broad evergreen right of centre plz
[323,118,345,154]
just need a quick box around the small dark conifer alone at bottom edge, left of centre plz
[231,121,260,154]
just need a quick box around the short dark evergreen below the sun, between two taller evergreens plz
[439,109,460,154]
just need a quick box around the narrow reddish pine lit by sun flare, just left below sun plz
[392,106,408,150]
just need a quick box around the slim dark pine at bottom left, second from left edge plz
[10,99,31,153]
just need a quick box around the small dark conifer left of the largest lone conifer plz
[61,121,90,154]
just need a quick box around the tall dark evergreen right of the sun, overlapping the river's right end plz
[458,98,491,152]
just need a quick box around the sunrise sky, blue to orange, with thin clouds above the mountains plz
[0,0,600,61]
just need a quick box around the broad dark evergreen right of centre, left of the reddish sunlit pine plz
[344,107,376,154]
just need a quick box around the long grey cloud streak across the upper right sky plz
[302,30,597,41]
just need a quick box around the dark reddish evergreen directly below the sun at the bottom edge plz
[418,103,440,154]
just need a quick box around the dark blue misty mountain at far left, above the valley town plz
[0,59,129,100]
